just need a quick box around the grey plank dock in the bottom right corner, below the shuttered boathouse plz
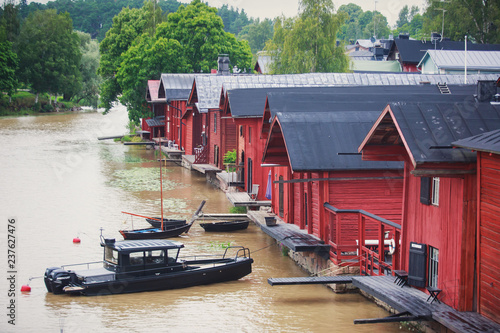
[352,276,500,333]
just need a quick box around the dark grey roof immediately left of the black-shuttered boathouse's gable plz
[276,111,403,171]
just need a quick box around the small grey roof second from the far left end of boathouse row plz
[158,74,200,102]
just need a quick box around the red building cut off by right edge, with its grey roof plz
[453,129,500,323]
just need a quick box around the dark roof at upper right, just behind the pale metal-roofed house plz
[389,39,500,64]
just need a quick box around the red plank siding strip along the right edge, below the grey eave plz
[478,153,500,323]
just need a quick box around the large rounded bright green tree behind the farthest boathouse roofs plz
[157,0,252,73]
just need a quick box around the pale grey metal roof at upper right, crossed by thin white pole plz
[417,50,500,71]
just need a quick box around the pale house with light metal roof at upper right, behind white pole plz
[417,50,500,74]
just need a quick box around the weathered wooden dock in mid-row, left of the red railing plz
[248,211,330,258]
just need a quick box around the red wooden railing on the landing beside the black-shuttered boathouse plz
[323,203,401,275]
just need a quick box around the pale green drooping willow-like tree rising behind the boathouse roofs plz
[266,0,349,74]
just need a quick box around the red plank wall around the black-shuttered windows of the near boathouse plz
[402,163,476,311]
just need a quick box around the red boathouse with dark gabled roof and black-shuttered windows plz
[359,96,500,311]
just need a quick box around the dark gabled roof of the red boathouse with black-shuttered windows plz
[358,101,500,167]
